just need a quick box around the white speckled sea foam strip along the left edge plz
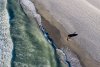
[0,0,13,67]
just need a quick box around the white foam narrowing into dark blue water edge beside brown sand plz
[19,0,71,67]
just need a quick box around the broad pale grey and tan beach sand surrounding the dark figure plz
[32,0,100,67]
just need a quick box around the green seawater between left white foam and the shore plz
[7,0,57,67]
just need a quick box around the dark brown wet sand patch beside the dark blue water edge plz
[42,17,63,48]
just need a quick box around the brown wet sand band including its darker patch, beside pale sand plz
[30,0,100,67]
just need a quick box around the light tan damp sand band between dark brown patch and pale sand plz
[31,0,100,67]
